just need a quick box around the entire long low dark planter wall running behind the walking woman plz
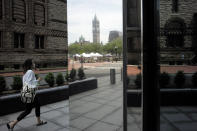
[0,78,98,116]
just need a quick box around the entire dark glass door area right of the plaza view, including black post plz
[123,0,197,131]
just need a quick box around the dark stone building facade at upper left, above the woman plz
[0,0,68,70]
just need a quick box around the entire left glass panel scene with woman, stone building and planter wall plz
[0,0,69,131]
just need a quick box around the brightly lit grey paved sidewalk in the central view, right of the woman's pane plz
[70,75,123,131]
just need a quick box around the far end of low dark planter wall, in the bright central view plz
[69,78,98,96]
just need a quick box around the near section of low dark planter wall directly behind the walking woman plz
[0,85,69,116]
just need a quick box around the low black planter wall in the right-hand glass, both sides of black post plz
[127,88,197,107]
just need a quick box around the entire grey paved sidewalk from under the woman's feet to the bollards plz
[0,74,123,131]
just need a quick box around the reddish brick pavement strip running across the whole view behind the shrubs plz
[0,61,197,77]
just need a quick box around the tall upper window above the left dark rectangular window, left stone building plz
[12,0,26,23]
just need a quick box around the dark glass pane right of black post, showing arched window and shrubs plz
[158,0,197,131]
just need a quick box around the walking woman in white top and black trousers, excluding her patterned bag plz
[7,59,47,129]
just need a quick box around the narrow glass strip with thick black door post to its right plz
[123,0,159,131]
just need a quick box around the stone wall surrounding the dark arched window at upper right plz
[160,0,197,64]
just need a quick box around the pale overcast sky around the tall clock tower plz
[67,0,122,44]
